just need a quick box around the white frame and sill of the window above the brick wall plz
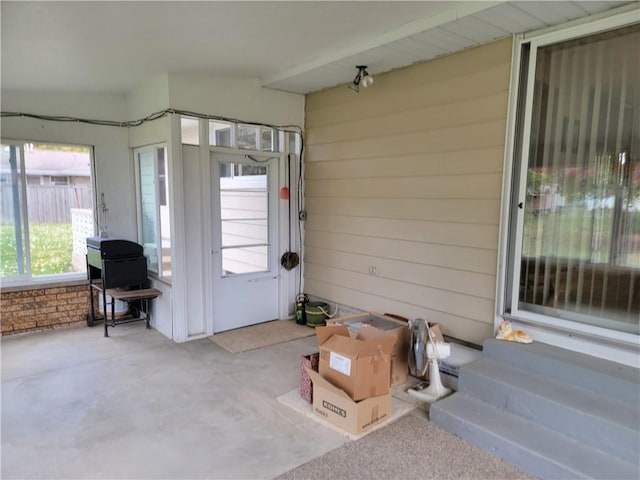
[0,138,98,289]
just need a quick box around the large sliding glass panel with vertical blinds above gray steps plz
[508,18,640,334]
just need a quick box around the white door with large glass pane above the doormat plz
[212,153,279,333]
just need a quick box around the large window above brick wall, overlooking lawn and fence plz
[0,142,95,282]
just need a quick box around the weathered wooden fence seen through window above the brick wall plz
[0,185,93,224]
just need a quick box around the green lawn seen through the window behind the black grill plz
[0,223,73,277]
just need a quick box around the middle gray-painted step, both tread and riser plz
[459,357,640,466]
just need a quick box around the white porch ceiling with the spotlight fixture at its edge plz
[0,0,629,93]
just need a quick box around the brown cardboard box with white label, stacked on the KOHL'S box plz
[316,325,396,401]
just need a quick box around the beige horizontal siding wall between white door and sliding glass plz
[304,40,511,343]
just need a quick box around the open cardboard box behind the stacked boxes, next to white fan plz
[327,312,409,387]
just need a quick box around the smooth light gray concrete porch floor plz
[1,322,348,479]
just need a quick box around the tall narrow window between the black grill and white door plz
[135,145,171,279]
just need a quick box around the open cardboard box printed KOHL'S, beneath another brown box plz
[307,369,391,435]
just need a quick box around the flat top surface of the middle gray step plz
[460,358,640,432]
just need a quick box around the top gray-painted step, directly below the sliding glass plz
[482,338,640,408]
